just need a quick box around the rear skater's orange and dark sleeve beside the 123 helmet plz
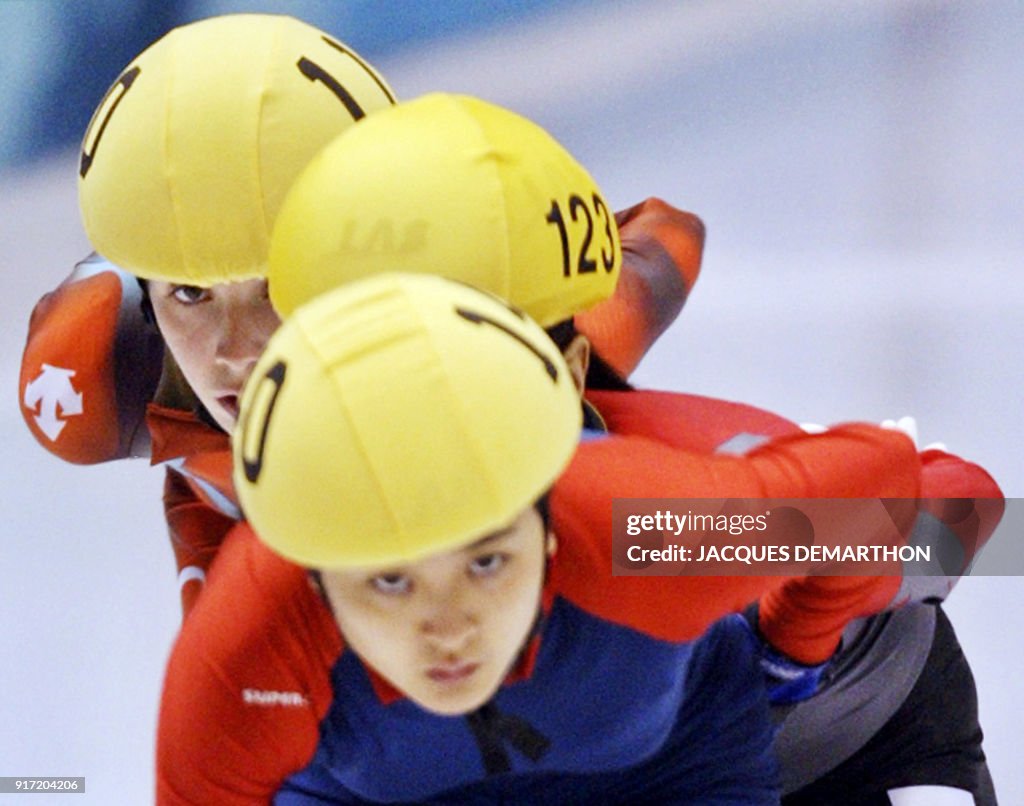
[575,199,705,378]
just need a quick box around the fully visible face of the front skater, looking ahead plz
[322,507,554,715]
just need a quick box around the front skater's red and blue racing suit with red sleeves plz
[158,413,921,804]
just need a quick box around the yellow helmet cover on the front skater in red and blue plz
[232,273,582,568]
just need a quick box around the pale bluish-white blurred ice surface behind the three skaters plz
[0,0,1024,804]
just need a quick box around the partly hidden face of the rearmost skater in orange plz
[148,279,281,432]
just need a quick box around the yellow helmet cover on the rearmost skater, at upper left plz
[78,14,394,286]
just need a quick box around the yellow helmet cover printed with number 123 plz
[268,93,622,327]
